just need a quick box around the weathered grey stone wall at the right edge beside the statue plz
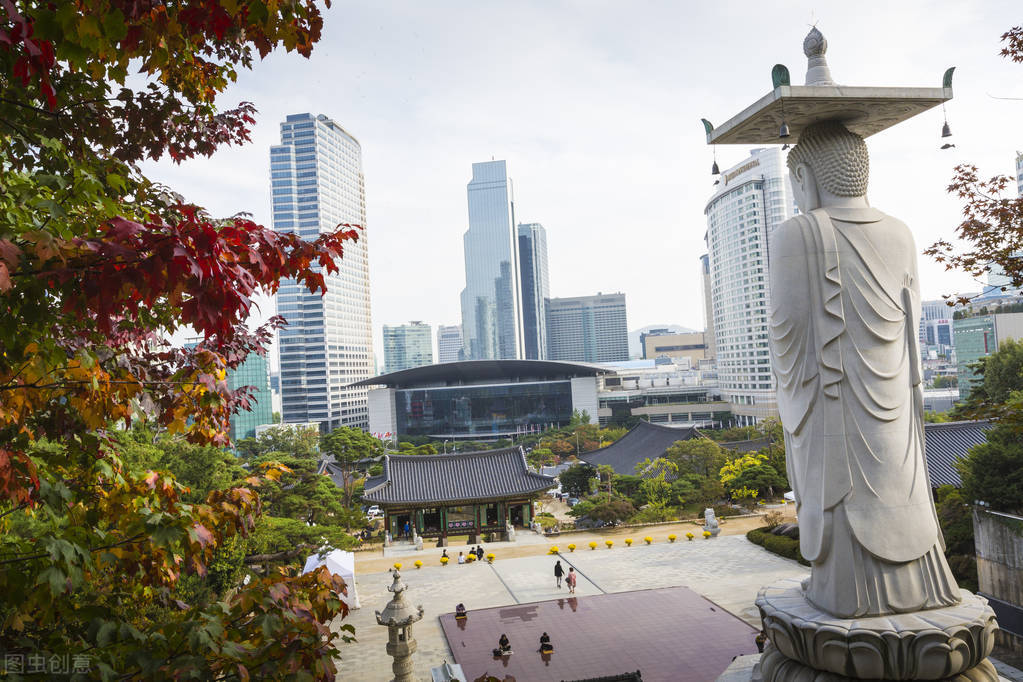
[973,508,1023,654]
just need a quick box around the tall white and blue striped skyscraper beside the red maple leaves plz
[270,113,373,430]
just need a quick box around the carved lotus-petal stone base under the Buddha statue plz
[756,579,998,682]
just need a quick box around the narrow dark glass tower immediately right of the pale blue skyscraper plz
[519,223,550,360]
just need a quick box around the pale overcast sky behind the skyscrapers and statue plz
[142,0,1023,364]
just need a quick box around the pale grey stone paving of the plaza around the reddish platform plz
[340,535,809,682]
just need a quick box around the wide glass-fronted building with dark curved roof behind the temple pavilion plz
[353,360,613,440]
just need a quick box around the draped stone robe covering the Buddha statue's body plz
[769,208,960,618]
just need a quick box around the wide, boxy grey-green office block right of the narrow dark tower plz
[547,292,629,362]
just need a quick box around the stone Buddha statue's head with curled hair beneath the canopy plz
[788,121,870,213]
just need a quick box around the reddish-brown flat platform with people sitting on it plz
[440,587,757,682]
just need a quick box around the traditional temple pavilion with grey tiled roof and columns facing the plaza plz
[362,446,558,547]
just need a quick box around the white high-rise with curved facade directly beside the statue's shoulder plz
[704,147,794,424]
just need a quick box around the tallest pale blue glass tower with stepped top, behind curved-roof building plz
[461,161,523,360]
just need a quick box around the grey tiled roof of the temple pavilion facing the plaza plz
[362,446,558,506]
